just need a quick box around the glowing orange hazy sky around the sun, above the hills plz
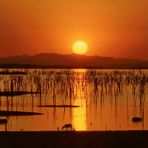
[0,0,148,59]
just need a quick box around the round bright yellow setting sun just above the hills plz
[72,41,88,54]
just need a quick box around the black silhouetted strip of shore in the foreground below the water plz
[0,130,148,148]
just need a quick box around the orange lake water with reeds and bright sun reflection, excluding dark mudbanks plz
[0,69,148,131]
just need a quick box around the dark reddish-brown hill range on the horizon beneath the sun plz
[0,53,148,68]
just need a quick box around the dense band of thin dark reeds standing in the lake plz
[0,69,148,123]
